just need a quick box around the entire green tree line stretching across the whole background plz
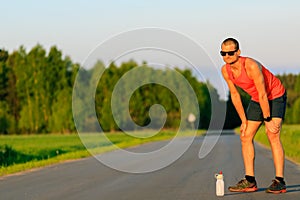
[0,45,300,134]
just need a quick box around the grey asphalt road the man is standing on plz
[0,131,300,200]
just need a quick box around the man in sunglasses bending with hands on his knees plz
[220,38,286,193]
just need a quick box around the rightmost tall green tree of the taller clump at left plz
[46,46,79,133]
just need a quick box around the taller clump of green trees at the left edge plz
[0,45,79,134]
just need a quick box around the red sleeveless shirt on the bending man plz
[226,56,285,102]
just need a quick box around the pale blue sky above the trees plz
[0,0,300,99]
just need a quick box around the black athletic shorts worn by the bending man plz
[246,92,287,121]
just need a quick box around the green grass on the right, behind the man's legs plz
[255,124,300,163]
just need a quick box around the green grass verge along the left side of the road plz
[0,130,204,176]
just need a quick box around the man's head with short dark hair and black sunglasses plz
[220,38,241,64]
